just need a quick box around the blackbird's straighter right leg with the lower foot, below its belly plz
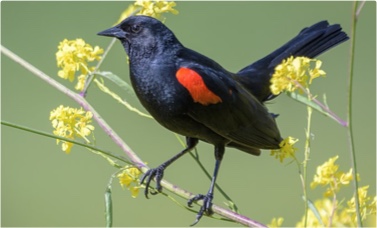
[187,145,225,226]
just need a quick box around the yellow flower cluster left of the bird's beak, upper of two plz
[56,39,103,91]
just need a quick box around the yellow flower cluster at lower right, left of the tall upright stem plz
[310,156,353,196]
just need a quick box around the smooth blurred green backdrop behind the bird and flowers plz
[1,1,376,226]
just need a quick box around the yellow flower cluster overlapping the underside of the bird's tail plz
[270,56,326,95]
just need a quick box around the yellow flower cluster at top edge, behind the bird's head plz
[117,0,178,24]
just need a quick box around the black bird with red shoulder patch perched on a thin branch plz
[98,16,348,224]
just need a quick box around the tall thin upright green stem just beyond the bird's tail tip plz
[347,1,363,227]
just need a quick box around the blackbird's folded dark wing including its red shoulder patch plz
[176,62,281,149]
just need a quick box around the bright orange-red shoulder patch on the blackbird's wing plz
[176,67,222,105]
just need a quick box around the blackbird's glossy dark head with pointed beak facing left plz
[97,16,181,59]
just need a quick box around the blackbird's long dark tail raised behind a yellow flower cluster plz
[236,21,349,102]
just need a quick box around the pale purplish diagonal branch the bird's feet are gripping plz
[1,45,265,227]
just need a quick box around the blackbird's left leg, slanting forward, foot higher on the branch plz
[140,137,199,198]
